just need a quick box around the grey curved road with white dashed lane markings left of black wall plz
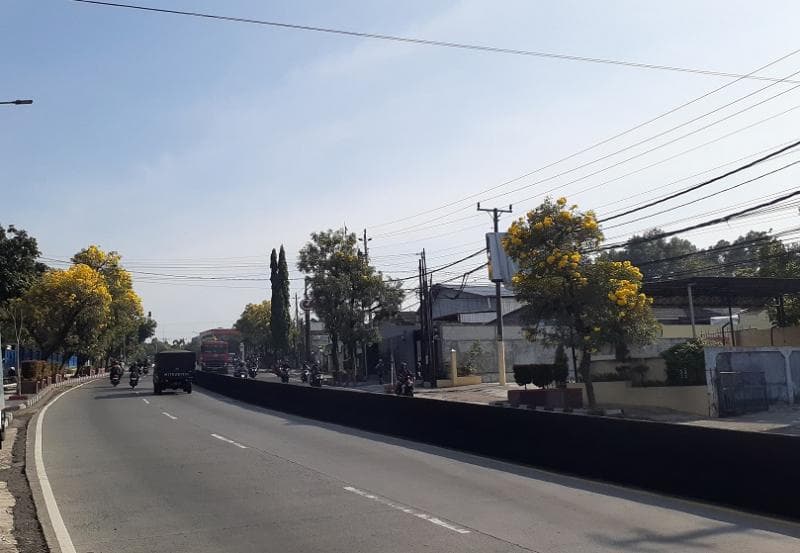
[37,377,800,553]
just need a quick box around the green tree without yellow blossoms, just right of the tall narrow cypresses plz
[296,226,403,372]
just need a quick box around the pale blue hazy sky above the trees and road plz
[0,0,800,339]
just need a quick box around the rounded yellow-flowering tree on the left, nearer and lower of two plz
[23,264,112,360]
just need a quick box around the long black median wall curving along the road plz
[195,371,800,519]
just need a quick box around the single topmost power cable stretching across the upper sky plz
[74,0,796,82]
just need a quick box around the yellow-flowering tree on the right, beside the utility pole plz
[504,198,657,407]
